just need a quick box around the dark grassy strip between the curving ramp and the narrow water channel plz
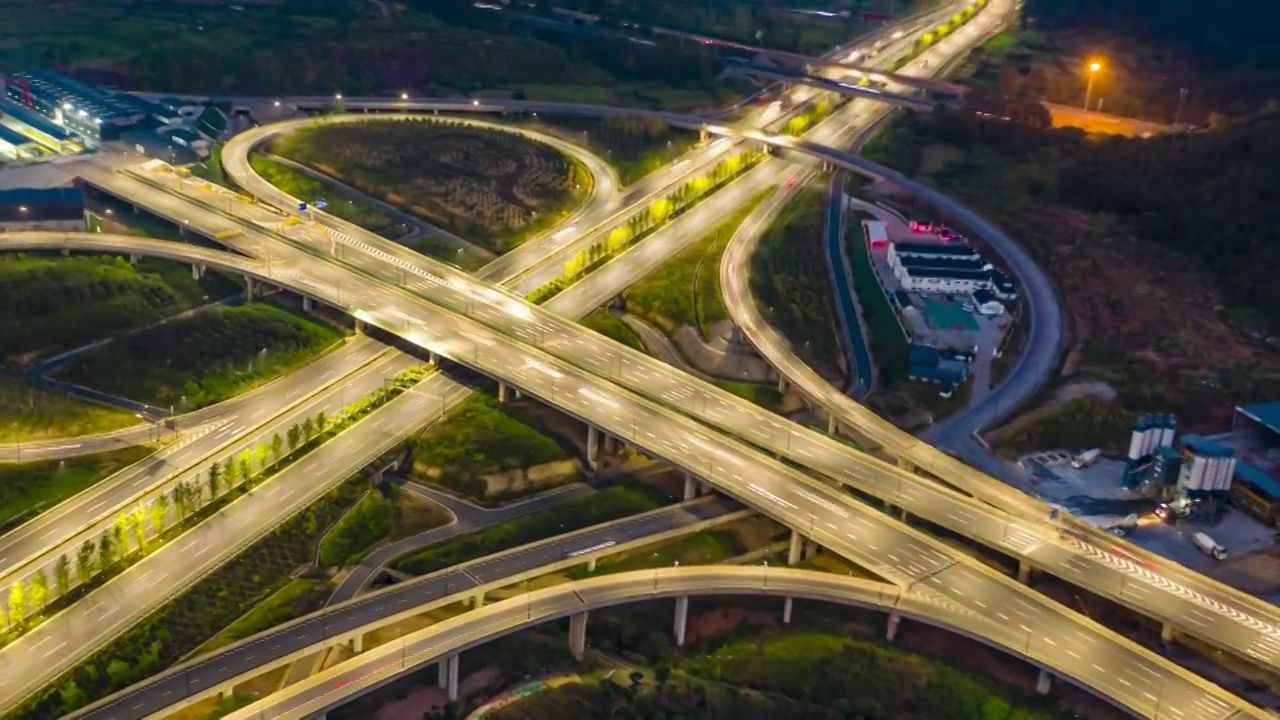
[751,190,842,378]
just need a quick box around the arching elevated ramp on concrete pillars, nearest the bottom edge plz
[149,566,1266,720]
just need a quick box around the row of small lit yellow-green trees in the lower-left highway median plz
[0,410,329,632]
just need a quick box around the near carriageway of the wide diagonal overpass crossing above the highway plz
[0,219,1259,717]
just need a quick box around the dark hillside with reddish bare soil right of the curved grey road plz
[867,106,1280,445]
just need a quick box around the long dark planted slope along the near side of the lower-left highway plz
[12,475,369,720]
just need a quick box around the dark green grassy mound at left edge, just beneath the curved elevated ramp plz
[0,255,233,357]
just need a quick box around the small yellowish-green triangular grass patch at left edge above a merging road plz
[0,375,138,443]
